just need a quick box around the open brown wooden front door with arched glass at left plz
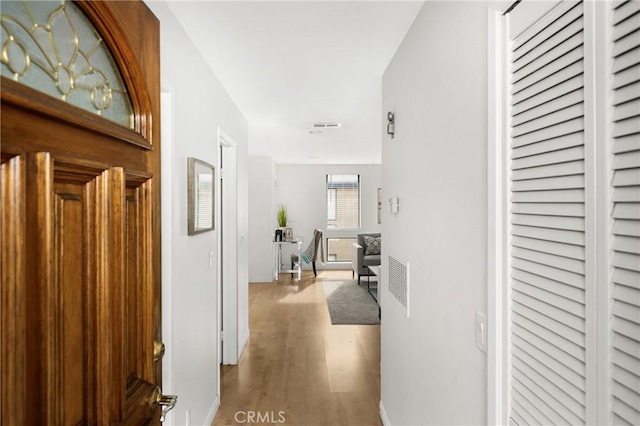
[0,1,166,426]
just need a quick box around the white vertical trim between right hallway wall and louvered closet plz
[487,0,516,425]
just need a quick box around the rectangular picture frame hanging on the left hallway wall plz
[187,157,216,235]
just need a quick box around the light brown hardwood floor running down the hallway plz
[213,271,382,426]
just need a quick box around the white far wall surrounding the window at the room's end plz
[271,164,384,269]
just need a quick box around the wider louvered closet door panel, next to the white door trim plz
[510,1,586,425]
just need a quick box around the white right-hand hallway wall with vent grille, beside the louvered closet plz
[381,1,488,425]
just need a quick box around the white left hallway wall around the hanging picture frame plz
[147,1,248,425]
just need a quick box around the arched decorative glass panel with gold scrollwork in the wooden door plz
[0,0,133,129]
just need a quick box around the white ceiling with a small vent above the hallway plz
[169,0,422,164]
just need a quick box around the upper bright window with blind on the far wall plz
[327,175,360,229]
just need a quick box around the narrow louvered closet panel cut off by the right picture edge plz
[611,1,640,425]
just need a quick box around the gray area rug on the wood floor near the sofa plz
[324,280,380,325]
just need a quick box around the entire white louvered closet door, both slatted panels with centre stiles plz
[496,0,640,425]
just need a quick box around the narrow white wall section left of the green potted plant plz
[249,156,276,282]
